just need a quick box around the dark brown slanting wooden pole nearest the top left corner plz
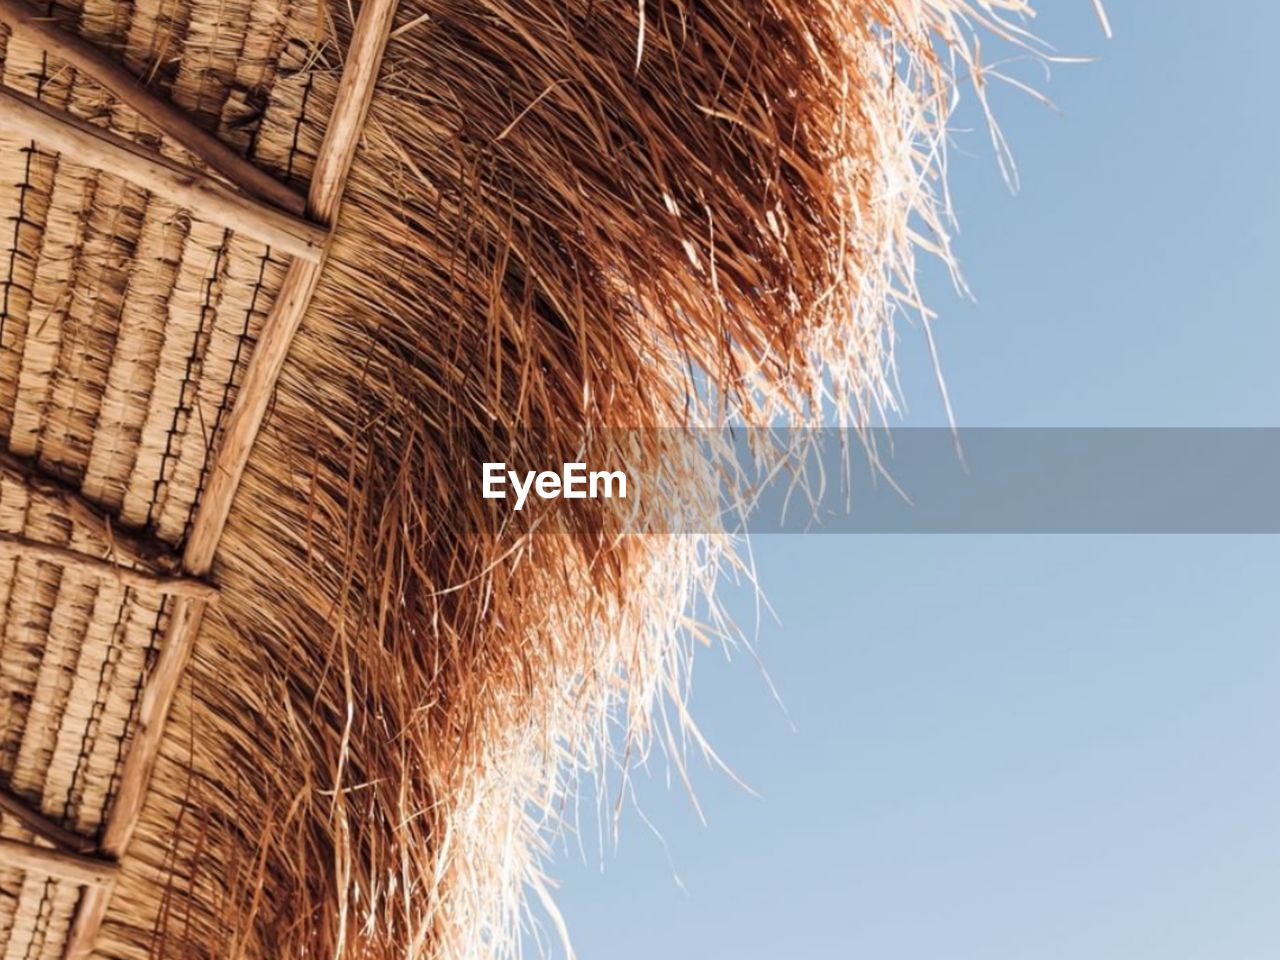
[0,0,306,216]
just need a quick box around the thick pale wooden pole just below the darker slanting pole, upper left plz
[0,87,329,261]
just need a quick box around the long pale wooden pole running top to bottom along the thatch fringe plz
[65,0,397,960]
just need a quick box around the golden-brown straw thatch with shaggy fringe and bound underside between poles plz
[0,0,1039,960]
